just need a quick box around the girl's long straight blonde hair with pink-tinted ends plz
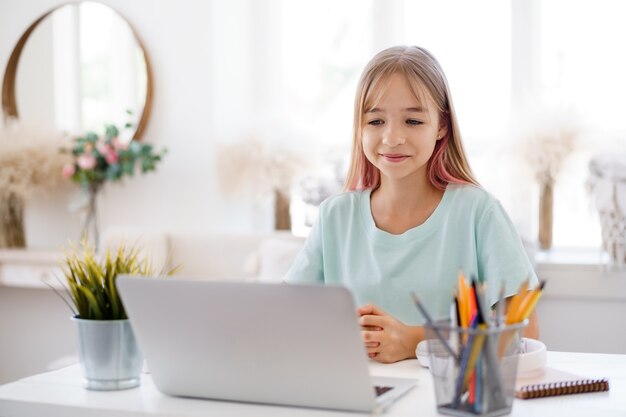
[344,46,478,191]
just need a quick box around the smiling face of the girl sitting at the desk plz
[362,74,447,186]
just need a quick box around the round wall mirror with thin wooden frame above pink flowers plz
[2,1,152,139]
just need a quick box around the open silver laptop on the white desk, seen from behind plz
[117,276,416,412]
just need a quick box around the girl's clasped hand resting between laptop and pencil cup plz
[357,304,424,363]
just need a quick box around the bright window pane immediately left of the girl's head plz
[280,0,373,236]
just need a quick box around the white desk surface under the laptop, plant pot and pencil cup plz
[0,352,626,417]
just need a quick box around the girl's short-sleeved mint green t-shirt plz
[285,185,537,325]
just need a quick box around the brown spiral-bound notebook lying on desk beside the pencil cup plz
[515,368,609,400]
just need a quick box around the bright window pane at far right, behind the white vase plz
[538,0,626,247]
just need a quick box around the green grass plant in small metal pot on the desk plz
[52,240,173,390]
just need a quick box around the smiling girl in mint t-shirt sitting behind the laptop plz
[285,46,538,363]
